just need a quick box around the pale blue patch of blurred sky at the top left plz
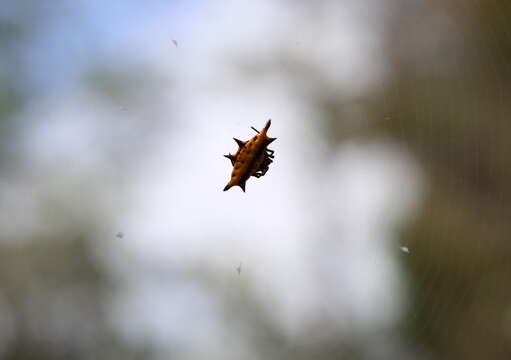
[2,0,198,91]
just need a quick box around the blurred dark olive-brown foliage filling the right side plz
[369,1,511,360]
